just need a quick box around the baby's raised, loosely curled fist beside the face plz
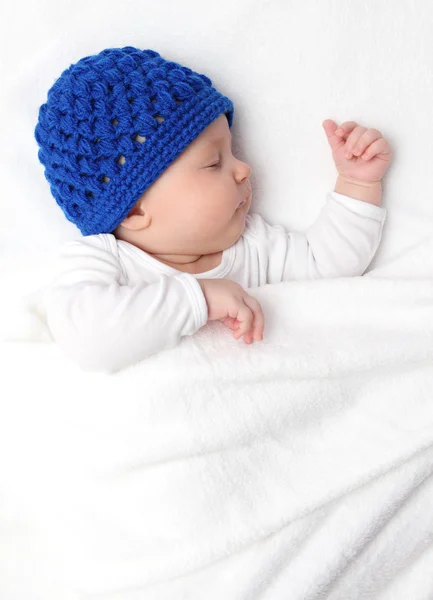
[322,119,392,182]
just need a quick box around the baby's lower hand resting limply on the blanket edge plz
[197,279,265,344]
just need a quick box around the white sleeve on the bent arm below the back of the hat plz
[45,236,207,372]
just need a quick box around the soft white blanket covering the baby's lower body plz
[0,231,433,600]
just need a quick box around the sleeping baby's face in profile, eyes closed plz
[116,115,251,255]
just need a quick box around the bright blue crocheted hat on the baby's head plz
[34,46,234,235]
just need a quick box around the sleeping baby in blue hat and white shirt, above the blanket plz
[35,46,392,372]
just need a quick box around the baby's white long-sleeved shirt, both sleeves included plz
[22,192,386,372]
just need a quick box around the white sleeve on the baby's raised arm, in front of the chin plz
[241,192,386,286]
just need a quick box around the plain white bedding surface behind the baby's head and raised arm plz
[0,0,433,268]
